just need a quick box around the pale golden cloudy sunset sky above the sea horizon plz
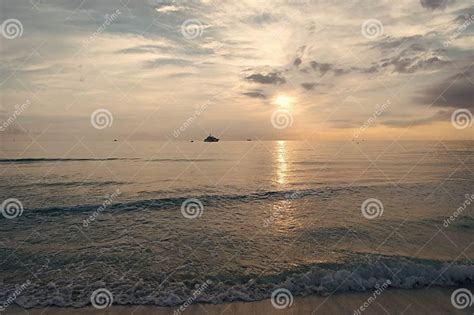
[0,0,474,140]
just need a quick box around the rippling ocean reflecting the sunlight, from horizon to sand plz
[0,139,474,307]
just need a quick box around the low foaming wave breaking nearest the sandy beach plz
[4,254,474,308]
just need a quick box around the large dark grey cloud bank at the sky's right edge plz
[416,65,474,109]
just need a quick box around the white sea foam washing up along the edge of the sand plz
[0,259,474,307]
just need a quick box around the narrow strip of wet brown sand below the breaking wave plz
[5,284,474,315]
